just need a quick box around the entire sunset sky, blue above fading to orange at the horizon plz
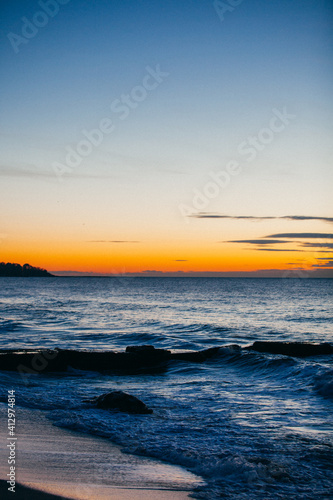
[0,0,333,277]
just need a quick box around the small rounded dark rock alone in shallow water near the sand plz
[90,391,153,414]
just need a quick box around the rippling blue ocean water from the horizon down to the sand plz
[0,277,333,500]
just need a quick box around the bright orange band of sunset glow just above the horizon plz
[1,236,322,274]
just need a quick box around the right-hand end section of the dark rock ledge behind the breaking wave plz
[244,341,333,358]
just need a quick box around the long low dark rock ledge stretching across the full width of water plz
[0,342,333,375]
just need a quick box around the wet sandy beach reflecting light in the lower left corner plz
[0,409,200,500]
